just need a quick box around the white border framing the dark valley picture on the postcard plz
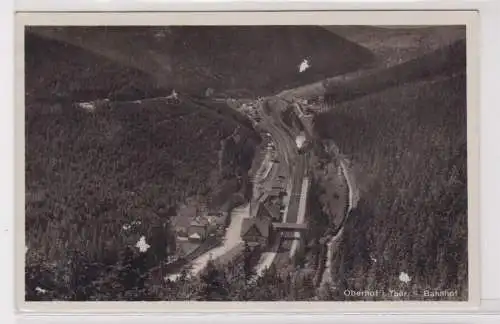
[15,10,480,314]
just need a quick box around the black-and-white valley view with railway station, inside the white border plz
[19,12,477,302]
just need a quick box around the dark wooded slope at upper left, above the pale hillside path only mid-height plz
[25,32,171,103]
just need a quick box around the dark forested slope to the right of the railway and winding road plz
[315,50,468,300]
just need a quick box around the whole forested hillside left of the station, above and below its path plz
[25,32,260,300]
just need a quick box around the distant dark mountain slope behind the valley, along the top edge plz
[30,26,373,97]
